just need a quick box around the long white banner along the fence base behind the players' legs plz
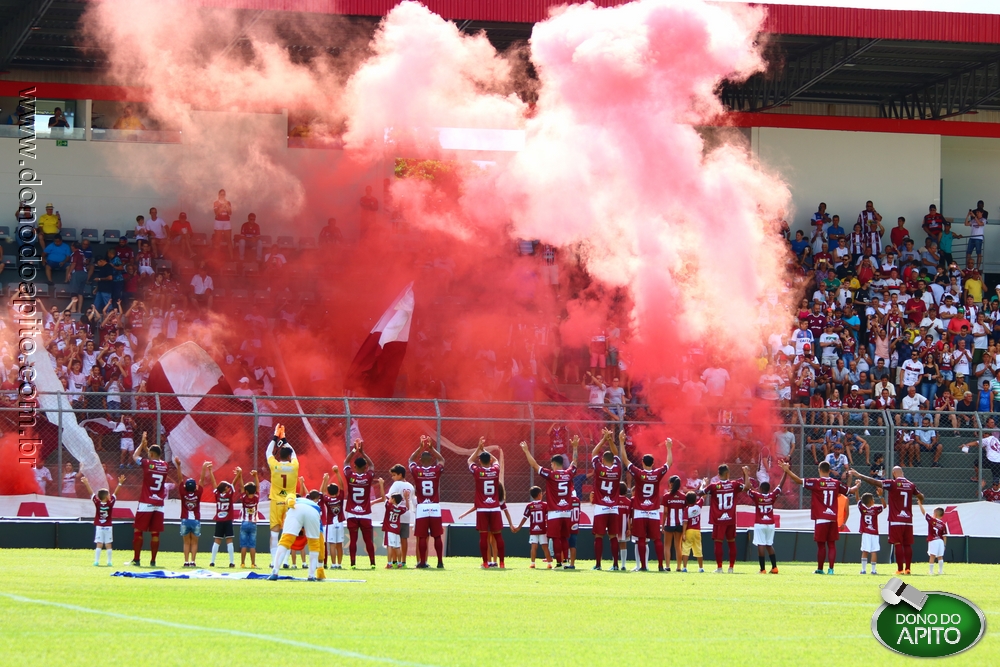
[7,494,1000,537]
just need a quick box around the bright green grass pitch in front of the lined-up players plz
[0,550,1000,667]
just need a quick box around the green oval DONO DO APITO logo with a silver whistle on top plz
[872,577,986,658]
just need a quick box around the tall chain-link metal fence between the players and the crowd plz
[0,394,1000,508]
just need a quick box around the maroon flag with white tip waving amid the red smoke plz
[344,283,413,398]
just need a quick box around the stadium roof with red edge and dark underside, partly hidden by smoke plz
[0,0,1000,119]
